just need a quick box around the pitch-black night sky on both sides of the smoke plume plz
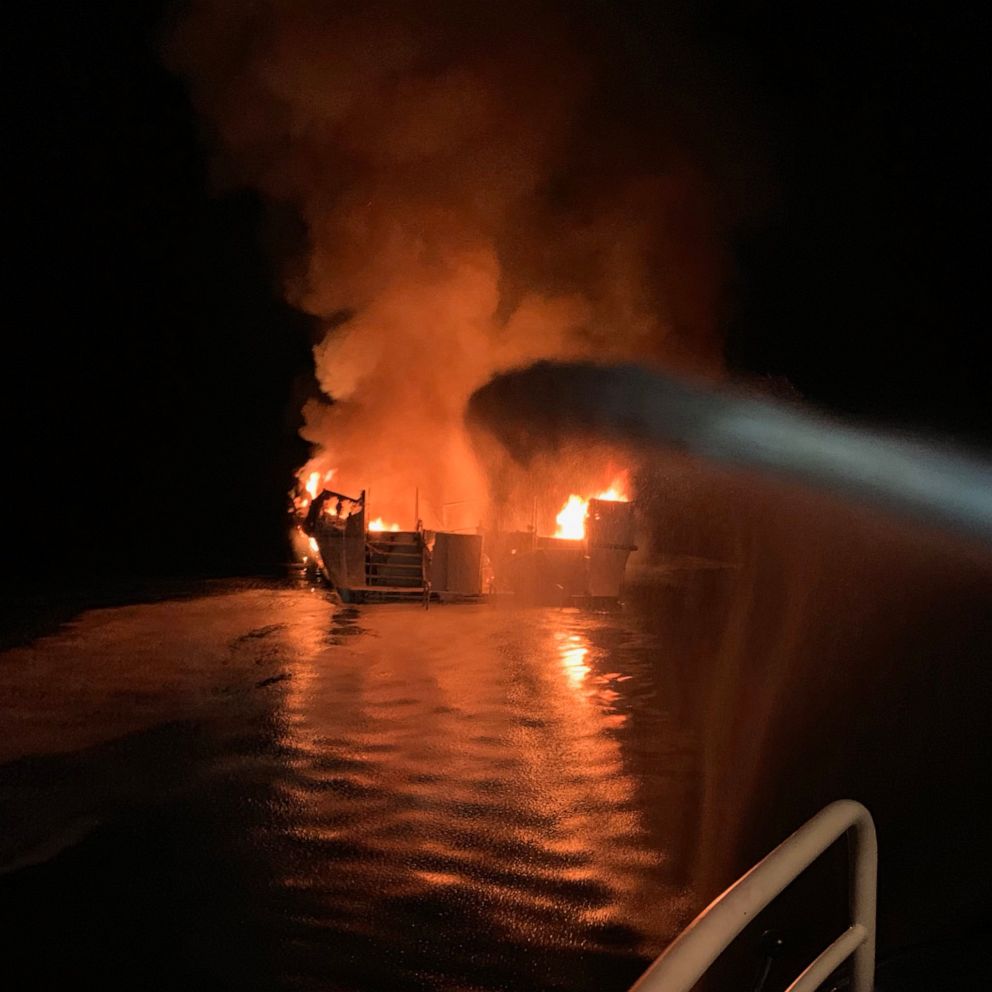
[3,0,992,584]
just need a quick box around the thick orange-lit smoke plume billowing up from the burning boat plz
[168,0,760,527]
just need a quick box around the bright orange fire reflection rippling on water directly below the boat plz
[264,608,685,988]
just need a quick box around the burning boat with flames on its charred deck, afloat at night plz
[301,480,636,605]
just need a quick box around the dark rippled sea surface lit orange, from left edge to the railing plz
[0,587,695,990]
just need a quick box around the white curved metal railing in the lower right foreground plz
[630,799,878,992]
